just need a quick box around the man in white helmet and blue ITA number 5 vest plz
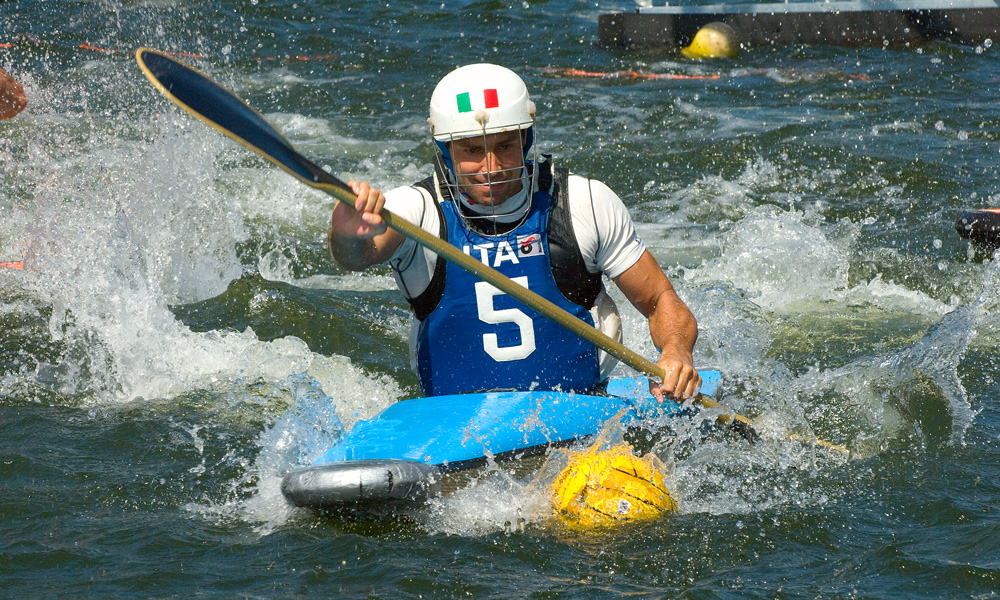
[329,64,701,400]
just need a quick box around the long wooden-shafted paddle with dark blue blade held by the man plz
[135,48,847,452]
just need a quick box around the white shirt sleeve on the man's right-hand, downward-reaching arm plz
[569,175,646,278]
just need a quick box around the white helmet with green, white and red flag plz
[427,63,535,145]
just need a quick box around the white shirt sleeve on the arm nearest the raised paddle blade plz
[385,186,441,299]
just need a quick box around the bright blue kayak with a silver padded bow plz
[281,370,722,510]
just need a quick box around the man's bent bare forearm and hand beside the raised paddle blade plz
[327,180,404,271]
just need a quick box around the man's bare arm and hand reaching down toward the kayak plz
[614,250,701,402]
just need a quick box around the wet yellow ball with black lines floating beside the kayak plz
[552,444,677,528]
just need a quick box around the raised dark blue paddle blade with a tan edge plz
[135,48,355,204]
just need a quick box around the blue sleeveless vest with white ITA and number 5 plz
[417,185,600,396]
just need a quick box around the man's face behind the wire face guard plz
[450,131,524,205]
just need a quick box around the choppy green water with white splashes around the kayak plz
[0,0,1000,598]
